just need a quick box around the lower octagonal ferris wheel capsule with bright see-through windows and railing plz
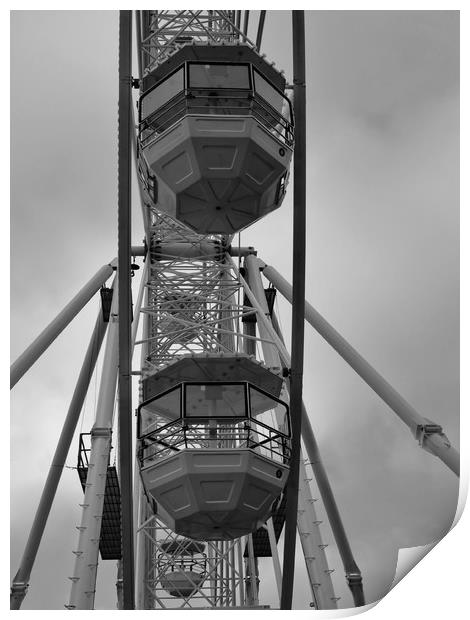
[138,354,290,540]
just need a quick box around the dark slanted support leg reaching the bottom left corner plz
[10,309,108,609]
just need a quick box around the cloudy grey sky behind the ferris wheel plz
[11,11,459,609]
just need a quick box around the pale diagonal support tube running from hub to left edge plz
[10,259,116,389]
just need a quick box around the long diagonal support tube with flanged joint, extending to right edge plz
[260,261,460,476]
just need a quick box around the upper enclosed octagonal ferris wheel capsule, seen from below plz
[139,45,293,234]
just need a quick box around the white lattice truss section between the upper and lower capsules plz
[136,209,255,376]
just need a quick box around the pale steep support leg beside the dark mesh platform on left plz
[67,282,118,609]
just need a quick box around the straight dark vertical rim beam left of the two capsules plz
[118,11,135,609]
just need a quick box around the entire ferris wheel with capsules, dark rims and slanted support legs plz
[11,10,459,609]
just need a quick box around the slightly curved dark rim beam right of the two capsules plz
[281,11,306,609]
